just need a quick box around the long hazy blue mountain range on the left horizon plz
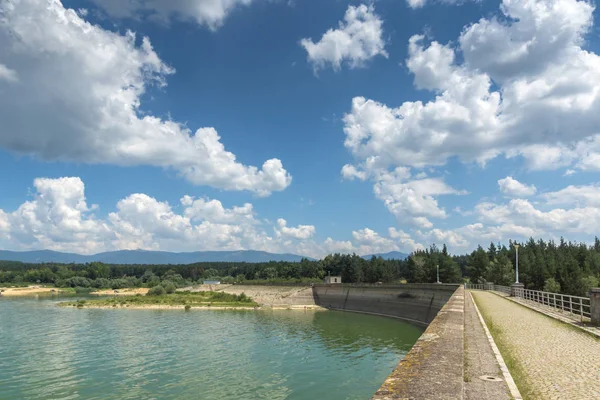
[0,250,313,264]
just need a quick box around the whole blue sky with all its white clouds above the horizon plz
[0,0,600,257]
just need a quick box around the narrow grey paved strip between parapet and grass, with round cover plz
[464,293,510,400]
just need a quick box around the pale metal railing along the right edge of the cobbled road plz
[465,283,592,322]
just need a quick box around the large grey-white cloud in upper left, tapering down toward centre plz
[0,0,291,196]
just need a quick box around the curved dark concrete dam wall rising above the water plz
[313,284,459,325]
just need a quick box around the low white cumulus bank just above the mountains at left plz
[0,177,421,257]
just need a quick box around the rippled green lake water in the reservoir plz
[0,298,422,400]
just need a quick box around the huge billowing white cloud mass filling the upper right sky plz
[344,0,600,175]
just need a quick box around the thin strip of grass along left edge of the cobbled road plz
[473,293,535,400]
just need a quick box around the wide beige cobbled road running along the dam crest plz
[472,291,600,400]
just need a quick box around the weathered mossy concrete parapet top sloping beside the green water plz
[371,287,465,400]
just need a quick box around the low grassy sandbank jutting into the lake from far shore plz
[58,292,258,309]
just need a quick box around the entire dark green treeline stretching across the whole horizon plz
[0,238,600,296]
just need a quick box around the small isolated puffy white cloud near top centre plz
[300,4,388,71]
